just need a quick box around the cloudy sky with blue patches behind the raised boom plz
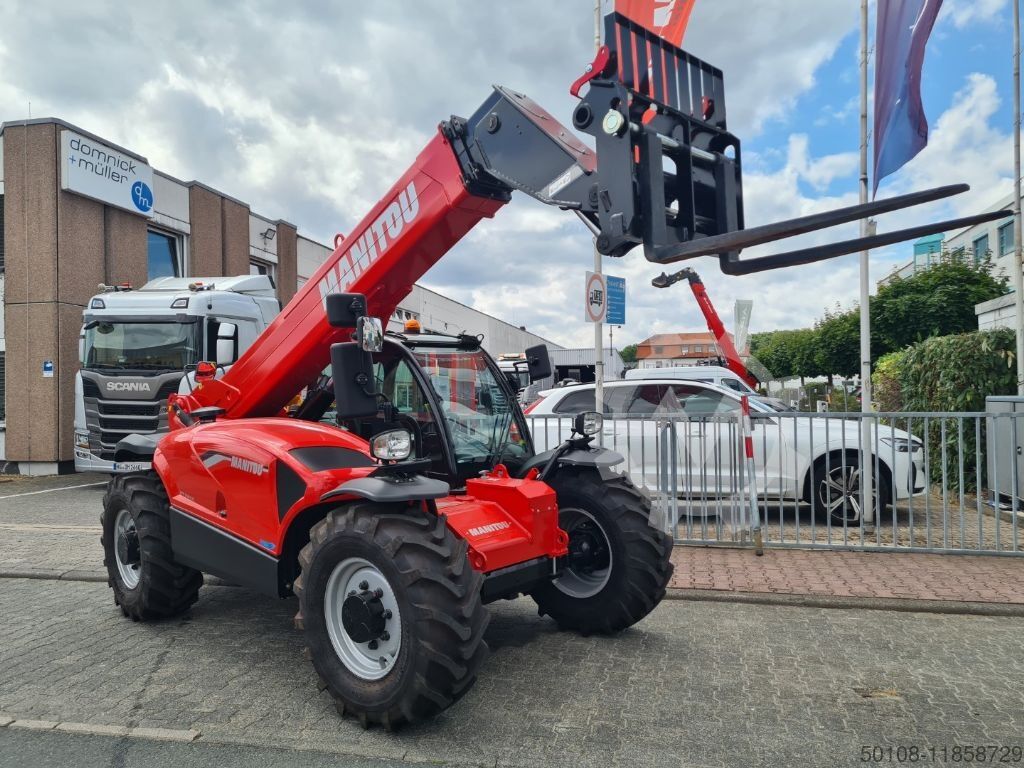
[0,0,1013,346]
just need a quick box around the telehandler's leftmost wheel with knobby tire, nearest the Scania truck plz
[99,472,203,622]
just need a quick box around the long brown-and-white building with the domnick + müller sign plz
[0,118,561,474]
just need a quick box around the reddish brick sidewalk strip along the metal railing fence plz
[672,547,1024,605]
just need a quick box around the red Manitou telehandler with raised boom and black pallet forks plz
[102,15,1006,728]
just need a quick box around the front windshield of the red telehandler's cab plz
[411,349,528,466]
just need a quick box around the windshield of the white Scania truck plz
[82,321,199,371]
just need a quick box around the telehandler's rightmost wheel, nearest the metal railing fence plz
[531,469,672,634]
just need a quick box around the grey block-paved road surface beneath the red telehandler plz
[0,478,1024,768]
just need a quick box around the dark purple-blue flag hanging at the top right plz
[874,0,942,191]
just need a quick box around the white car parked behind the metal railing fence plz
[527,379,925,523]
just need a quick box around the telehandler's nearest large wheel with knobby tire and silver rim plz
[294,501,489,730]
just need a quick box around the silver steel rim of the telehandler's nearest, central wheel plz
[324,557,401,680]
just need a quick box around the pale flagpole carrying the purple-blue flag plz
[860,0,874,526]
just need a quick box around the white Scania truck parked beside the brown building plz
[75,275,281,472]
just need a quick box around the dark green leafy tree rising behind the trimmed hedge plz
[870,259,1007,356]
